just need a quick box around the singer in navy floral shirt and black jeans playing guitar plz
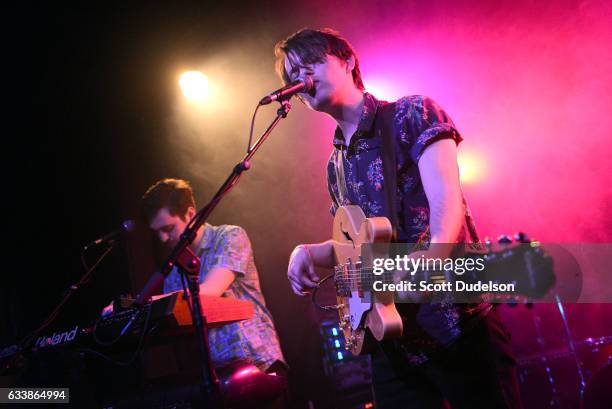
[275,29,522,409]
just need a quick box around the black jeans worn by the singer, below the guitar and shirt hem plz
[372,310,523,409]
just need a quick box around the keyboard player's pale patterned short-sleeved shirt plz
[164,224,285,371]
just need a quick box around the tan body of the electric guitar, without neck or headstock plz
[332,206,403,355]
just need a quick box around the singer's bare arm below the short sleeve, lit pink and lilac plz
[418,139,463,250]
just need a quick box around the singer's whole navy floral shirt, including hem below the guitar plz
[327,93,490,364]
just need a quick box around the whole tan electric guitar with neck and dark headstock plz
[332,205,555,355]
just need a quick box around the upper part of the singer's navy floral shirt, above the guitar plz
[327,93,462,243]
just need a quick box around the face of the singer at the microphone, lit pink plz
[285,53,353,111]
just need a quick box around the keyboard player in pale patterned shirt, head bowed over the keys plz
[131,179,287,376]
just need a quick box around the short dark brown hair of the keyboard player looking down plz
[142,179,195,222]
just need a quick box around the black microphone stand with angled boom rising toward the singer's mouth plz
[138,99,291,408]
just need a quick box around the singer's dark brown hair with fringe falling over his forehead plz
[274,28,365,91]
